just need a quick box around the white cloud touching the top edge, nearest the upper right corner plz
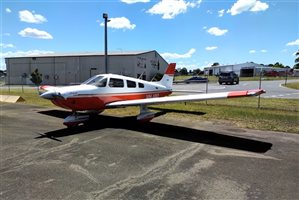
[227,0,269,15]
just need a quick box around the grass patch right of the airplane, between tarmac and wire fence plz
[150,101,299,133]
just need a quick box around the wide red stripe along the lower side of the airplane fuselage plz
[52,91,171,111]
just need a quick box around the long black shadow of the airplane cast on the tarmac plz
[36,110,272,153]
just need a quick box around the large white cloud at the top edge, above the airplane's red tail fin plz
[147,0,201,19]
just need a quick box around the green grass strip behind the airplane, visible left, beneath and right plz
[1,88,299,133]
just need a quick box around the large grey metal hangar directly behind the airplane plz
[5,50,168,85]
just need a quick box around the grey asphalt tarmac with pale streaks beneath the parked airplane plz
[0,104,299,200]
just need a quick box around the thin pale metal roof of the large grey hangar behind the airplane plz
[6,50,155,58]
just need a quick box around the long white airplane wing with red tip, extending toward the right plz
[106,89,265,107]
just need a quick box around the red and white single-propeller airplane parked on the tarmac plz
[39,63,265,127]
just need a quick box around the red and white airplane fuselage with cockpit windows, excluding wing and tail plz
[41,74,172,111]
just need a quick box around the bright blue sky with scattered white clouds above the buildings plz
[0,0,299,69]
